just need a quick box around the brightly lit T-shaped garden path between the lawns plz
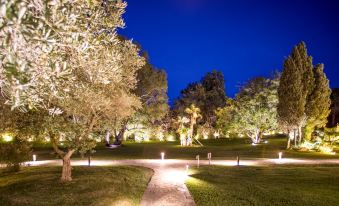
[28,158,339,206]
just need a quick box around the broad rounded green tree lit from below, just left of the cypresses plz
[226,77,279,143]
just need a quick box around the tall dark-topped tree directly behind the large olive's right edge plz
[115,53,169,144]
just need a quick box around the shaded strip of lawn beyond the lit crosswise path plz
[35,138,339,160]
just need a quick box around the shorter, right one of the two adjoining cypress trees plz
[305,64,331,140]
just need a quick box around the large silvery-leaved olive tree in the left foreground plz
[0,0,144,181]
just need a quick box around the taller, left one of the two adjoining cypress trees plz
[277,42,314,147]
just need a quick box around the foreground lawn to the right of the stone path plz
[186,166,339,206]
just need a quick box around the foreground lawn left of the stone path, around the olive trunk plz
[0,166,153,206]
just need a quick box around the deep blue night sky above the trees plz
[120,0,339,102]
